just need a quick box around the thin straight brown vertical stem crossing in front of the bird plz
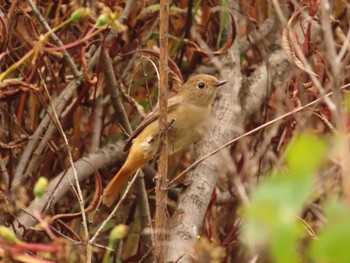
[155,0,169,263]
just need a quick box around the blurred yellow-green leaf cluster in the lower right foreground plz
[242,133,326,263]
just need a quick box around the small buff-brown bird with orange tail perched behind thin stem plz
[103,74,227,206]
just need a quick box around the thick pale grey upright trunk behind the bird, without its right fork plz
[167,0,241,263]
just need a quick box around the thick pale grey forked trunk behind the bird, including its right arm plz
[168,1,291,262]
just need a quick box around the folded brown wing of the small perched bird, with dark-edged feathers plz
[124,96,181,152]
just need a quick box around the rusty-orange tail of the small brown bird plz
[103,149,149,207]
